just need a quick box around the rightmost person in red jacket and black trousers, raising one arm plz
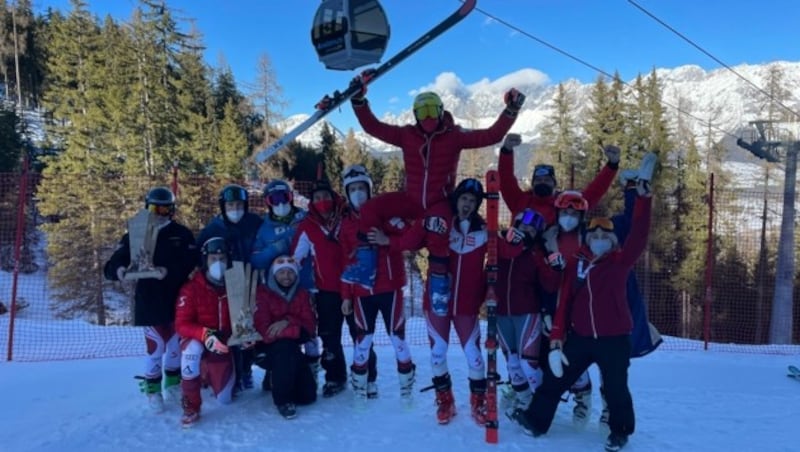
[516,180,651,451]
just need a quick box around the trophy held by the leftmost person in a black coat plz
[125,209,161,281]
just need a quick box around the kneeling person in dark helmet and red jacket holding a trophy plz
[175,237,235,427]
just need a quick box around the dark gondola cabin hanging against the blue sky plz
[311,0,389,71]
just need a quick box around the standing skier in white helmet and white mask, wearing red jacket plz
[340,165,416,399]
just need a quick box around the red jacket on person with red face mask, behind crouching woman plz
[291,198,343,293]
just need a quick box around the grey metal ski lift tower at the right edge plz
[736,120,800,344]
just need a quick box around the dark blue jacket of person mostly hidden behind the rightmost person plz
[611,188,662,358]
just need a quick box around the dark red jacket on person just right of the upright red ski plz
[495,237,561,315]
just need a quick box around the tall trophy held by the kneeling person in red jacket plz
[225,261,261,345]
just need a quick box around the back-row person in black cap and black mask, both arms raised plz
[497,133,620,225]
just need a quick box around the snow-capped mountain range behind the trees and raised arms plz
[285,61,800,185]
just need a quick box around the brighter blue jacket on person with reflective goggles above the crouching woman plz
[250,207,314,290]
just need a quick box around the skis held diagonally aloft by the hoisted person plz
[255,0,477,163]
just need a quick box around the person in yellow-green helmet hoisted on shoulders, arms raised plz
[342,81,525,308]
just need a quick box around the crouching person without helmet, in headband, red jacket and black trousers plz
[253,256,317,419]
